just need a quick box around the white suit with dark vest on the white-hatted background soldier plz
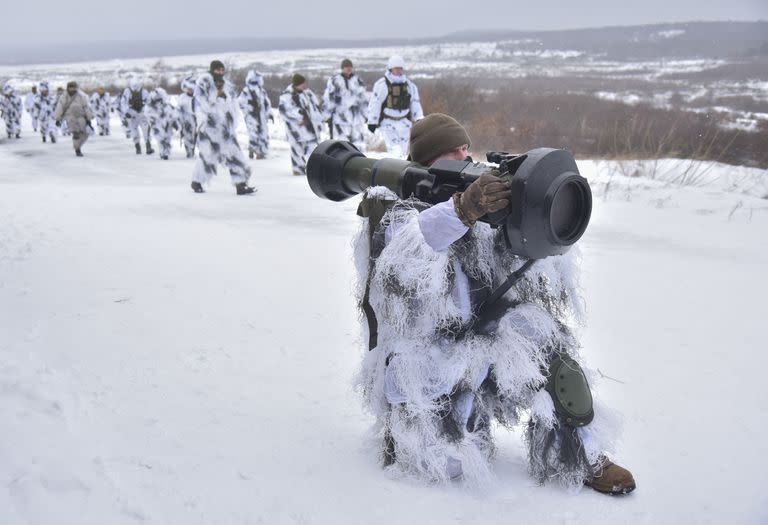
[368,71,424,158]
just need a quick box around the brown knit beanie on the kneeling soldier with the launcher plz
[408,113,471,164]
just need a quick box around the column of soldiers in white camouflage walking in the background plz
[0,56,424,188]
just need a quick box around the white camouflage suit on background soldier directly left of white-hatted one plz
[323,73,368,150]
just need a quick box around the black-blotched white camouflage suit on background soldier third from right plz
[278,85,323,175]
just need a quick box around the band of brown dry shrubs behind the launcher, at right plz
[420,79,768,168]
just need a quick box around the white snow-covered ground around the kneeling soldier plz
[0,117,768,525]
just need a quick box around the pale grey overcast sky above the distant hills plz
[7,0,768,46]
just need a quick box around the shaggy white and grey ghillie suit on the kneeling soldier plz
[355,187,616,490]
